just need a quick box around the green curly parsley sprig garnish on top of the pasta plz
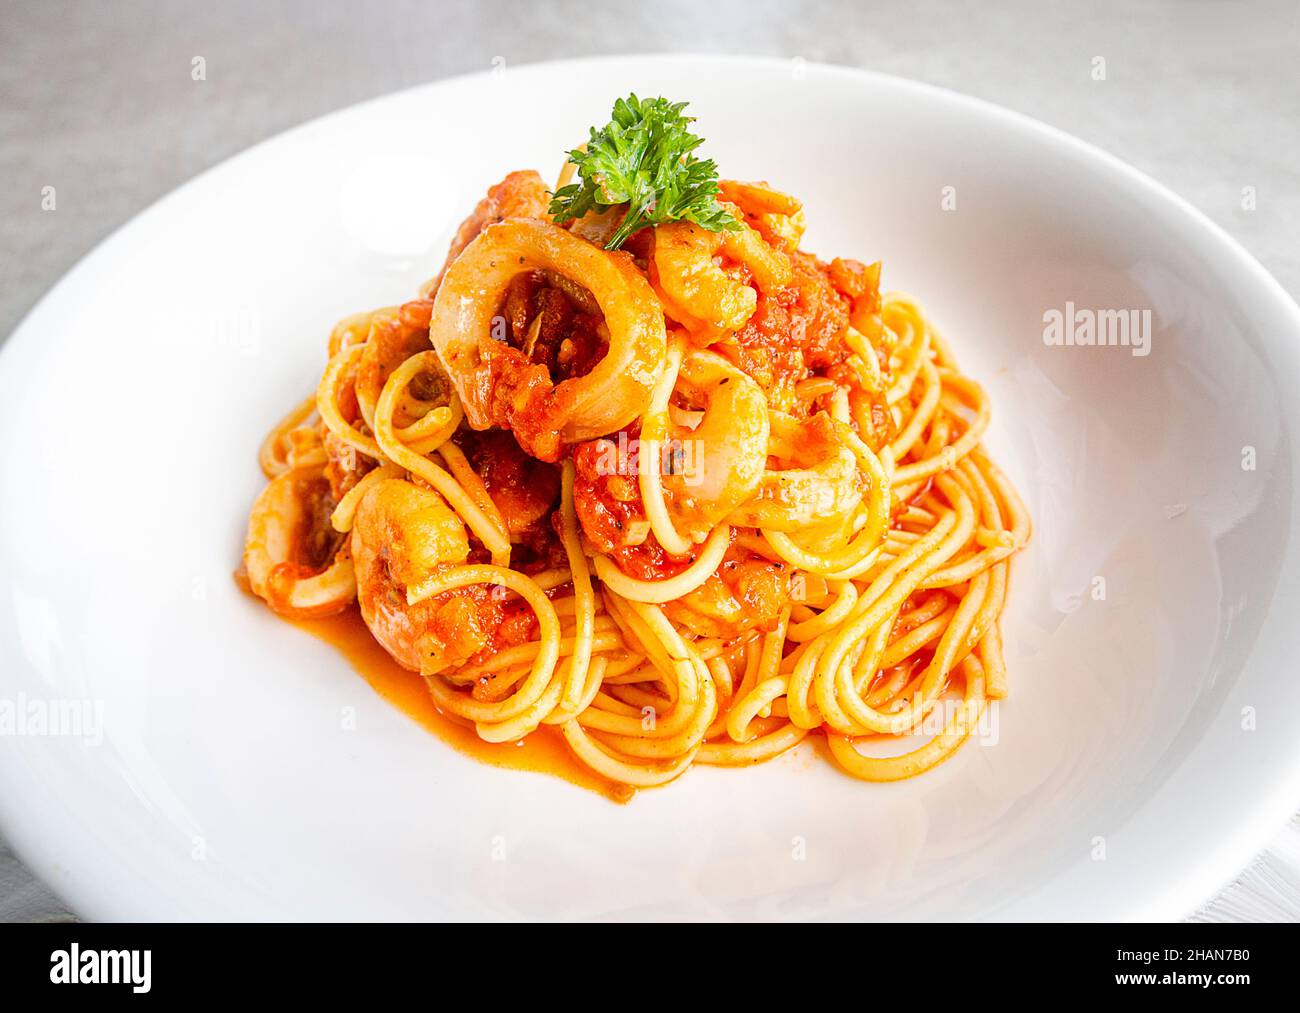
[550,95,741,250]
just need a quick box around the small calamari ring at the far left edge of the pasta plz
[243,468,356,619]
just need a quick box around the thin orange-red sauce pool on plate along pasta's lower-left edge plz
[289,607,636,802]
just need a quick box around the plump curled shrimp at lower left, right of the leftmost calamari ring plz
[352,479,534,675]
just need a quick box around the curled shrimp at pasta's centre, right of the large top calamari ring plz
[663,351,768,532]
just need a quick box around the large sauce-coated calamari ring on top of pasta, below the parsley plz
[429,218,667,460]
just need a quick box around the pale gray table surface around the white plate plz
[0,0,1300,921]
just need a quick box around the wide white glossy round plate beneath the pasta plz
[0,57,1300,918]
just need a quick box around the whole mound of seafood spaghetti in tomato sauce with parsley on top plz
[242,96,1030,788]
